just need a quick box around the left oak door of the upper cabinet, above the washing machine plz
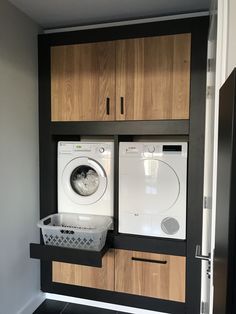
[51,42,115,121]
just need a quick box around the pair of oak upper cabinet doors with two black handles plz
[51,34,191,121]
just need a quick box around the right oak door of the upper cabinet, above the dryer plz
[116,34,191,120]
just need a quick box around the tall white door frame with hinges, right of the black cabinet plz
[201,0,229,314]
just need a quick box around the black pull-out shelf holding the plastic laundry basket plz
[30,243,109,267]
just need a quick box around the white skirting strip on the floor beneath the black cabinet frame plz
[45,293,168,314]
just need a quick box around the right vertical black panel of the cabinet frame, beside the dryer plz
[186,20,208,314]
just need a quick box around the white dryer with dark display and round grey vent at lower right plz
[119,142,187,239]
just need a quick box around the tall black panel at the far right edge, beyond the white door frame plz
[214,70,236,314]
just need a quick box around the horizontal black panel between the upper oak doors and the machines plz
[50,120,189,135]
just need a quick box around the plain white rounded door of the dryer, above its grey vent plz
[120,158,180,215]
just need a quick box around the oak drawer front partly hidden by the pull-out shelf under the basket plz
[52,250,115,291]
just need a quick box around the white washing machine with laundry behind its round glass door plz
[58,142,114,216]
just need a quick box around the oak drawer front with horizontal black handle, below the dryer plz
[115,250,186,302]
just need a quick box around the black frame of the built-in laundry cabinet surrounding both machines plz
[34,17,209,314]
